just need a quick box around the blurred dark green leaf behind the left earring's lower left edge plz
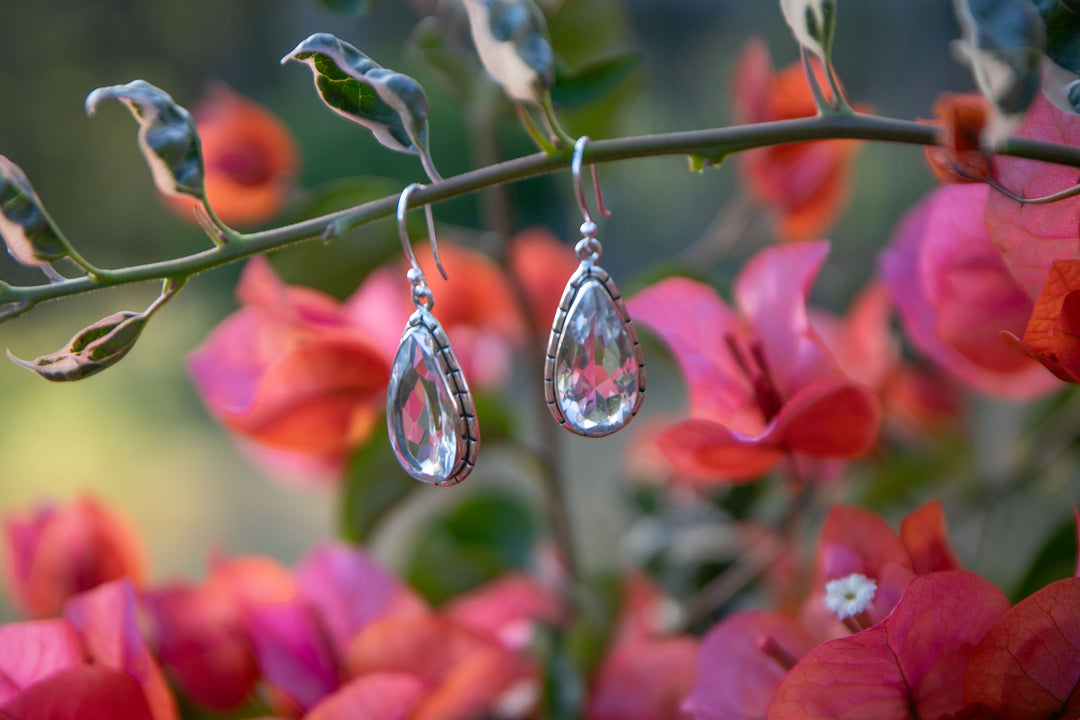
[341,422,426,543]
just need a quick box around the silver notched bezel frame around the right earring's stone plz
[543,260,645,437]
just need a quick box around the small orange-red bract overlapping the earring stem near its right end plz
[927,93,990,182]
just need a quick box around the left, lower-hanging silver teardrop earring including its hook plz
[387,184,480,486]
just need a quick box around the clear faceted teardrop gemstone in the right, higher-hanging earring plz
[554,274,639,437]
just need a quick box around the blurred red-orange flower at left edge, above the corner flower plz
[3,498,145,617]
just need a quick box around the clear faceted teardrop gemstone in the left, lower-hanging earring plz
[387,325,461,483]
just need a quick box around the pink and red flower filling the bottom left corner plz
[0,580,179,720]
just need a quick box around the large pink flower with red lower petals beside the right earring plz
[627,242,881,481]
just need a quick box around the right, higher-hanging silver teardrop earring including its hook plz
[544,137,645,437]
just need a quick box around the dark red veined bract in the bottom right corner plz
[963,578,1080,720]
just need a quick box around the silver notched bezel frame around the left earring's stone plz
[387,309,480,487]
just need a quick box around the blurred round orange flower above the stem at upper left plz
[167,85,298,227]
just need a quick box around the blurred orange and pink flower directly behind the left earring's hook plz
[347,242,524,389]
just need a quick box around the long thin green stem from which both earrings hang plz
[0,113,1080,313]
